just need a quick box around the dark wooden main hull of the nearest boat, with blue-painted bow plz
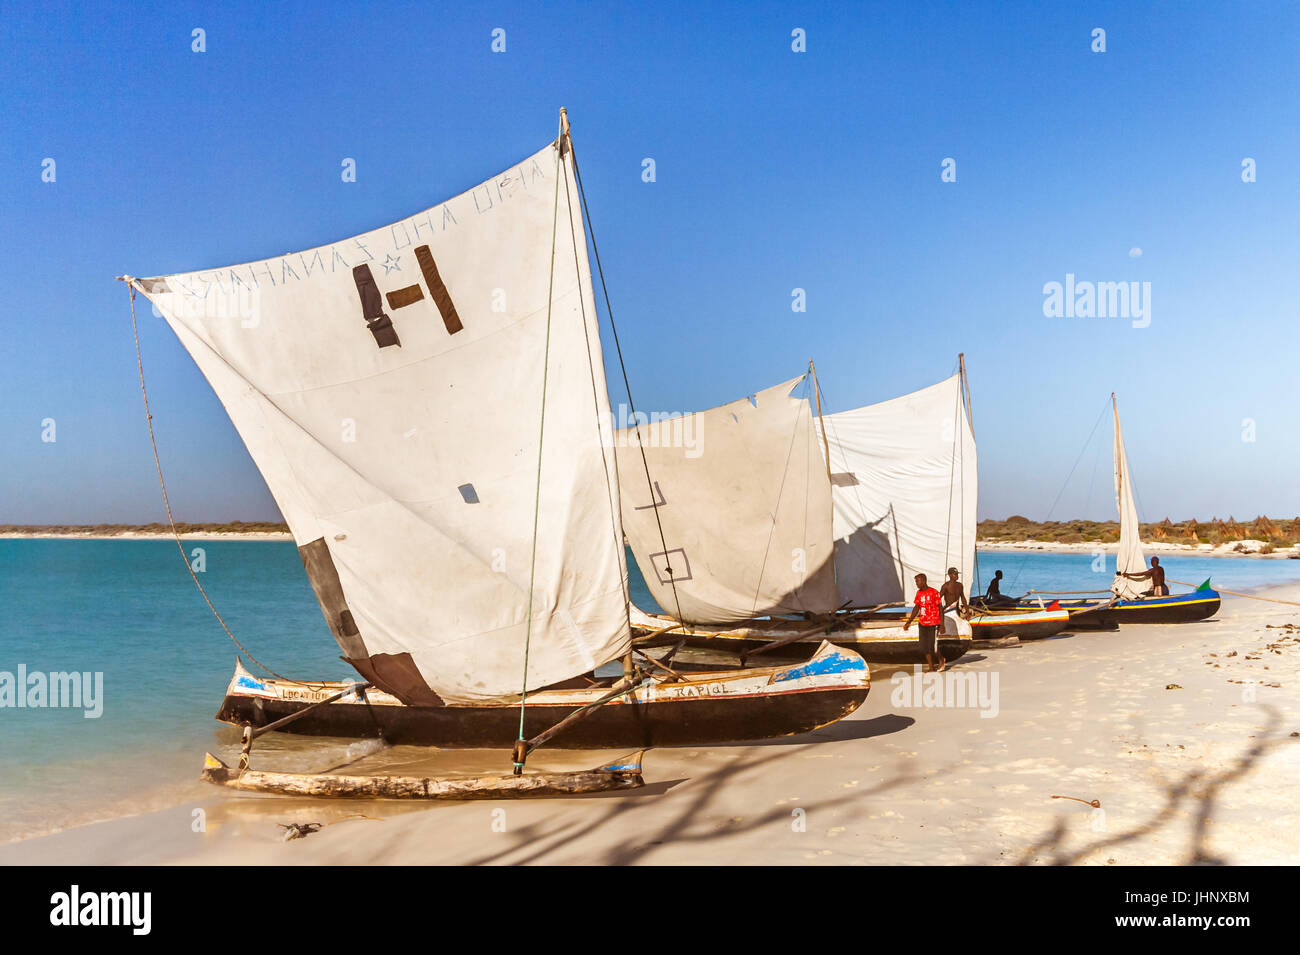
[217,643,871,750]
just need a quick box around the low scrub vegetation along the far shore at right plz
[979,515,1300,552]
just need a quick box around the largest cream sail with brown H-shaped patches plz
[137,138,629,703]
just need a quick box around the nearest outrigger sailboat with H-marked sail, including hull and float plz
[124,110,870,798]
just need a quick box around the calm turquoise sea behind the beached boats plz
[0,541,1300,842]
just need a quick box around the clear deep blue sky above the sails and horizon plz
[0,1,1300,522]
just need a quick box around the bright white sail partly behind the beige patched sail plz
[823,374,979,607]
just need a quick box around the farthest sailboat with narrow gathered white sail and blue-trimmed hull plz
[1019,394,1221,630]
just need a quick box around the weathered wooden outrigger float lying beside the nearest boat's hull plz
[200,752,645,799]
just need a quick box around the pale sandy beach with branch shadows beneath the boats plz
[0,586,1300,865]
